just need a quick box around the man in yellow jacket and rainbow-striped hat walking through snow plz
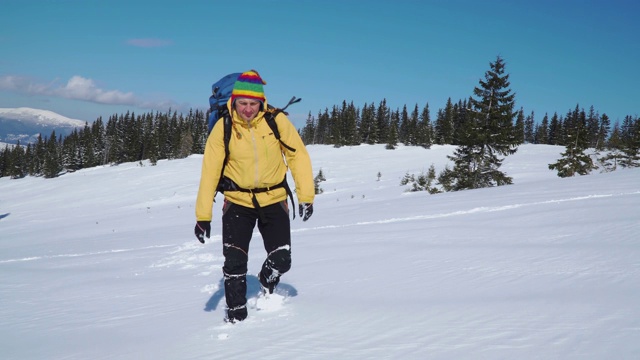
[195,70,315,323]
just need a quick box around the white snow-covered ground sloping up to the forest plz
[0,145,640,360]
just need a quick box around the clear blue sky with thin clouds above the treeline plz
[0,0,640,126]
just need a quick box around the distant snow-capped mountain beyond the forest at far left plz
[0,107,85,144]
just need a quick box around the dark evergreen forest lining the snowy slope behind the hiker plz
[0,57,640,191]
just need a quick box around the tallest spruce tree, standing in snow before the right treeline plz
[439,56,520,191]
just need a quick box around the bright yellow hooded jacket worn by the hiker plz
[196,100,315,221]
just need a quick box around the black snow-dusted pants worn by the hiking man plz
[222,201,291,320]
